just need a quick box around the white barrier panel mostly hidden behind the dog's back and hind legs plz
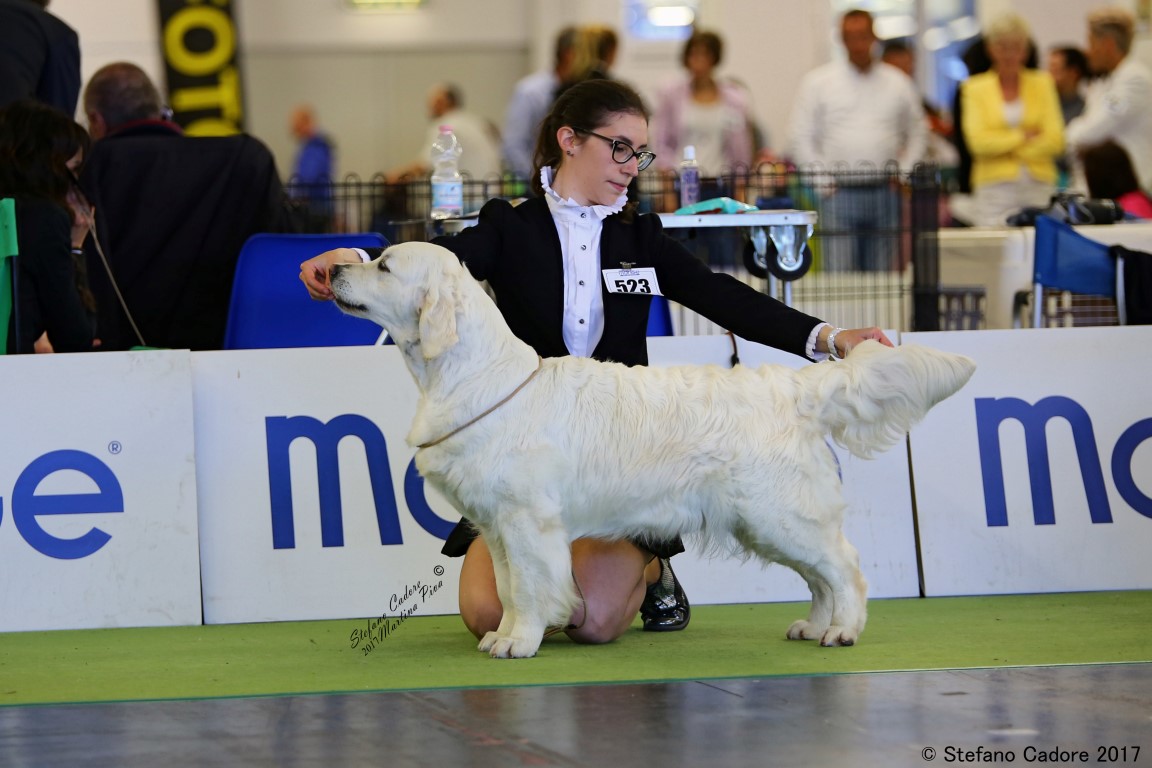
[649,332,919,604]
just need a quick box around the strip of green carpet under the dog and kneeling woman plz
[0,591,1152,705]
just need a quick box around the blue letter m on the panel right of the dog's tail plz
[976,396,1112,526]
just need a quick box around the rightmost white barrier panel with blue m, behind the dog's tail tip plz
[903,326,1152,595]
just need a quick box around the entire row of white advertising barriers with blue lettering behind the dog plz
[9,327,1152,641]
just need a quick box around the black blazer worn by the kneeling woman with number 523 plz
[375,197,820,365]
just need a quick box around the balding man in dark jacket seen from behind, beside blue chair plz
[81,62,293,350]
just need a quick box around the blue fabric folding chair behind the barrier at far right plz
[1032,216,1126,328]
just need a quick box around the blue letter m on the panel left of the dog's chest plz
[264,413,403,549]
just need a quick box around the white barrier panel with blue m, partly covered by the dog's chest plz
[192,347,460,629]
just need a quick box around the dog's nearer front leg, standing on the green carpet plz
[480,507,576,659]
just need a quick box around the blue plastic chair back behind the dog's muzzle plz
[223,233,388,349]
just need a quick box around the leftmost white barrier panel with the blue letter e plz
[0,351,200,631]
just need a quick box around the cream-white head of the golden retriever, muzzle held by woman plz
[332,242,467,359]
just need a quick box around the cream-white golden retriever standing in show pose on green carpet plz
[332,243,975,657]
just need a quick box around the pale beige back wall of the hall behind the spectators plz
[52,0,1152,175]
